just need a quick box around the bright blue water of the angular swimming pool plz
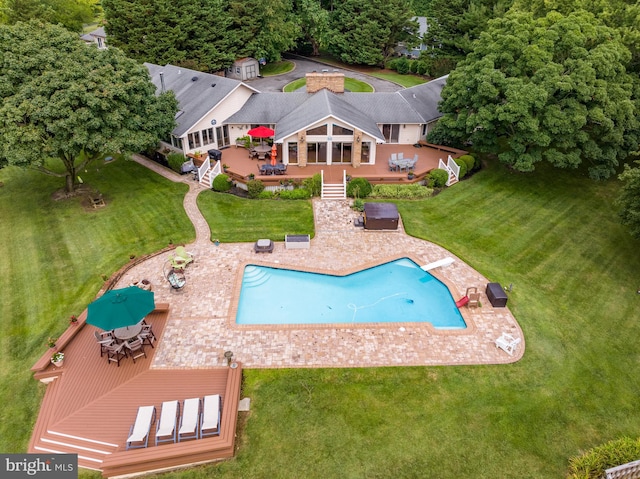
[236,258,467,329]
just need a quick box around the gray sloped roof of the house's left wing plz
[144,63,256,137]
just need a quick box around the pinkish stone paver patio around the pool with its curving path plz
[121,156,524,368]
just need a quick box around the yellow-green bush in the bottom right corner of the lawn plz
[567,437,640,479]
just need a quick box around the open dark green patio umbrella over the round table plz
[87,286,156,331]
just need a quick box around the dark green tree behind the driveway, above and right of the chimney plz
[328,0,419,66]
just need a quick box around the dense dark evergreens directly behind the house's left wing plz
[103,0,236,72]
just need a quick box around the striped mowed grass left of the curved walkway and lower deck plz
[0,160,195,452]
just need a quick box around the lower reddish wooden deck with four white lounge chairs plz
[28,304,242,477]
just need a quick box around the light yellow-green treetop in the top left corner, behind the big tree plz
[2,0,100,32]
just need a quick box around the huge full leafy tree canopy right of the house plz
[429,12,638,178]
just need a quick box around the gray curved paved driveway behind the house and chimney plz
[245,57,403,92]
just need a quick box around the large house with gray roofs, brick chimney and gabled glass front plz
[145,64,446,167]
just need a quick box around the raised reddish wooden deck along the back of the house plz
[215,144,466,186]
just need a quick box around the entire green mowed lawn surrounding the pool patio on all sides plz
[0,161,640,479]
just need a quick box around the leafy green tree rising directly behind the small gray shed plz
[229,0,300,61]
